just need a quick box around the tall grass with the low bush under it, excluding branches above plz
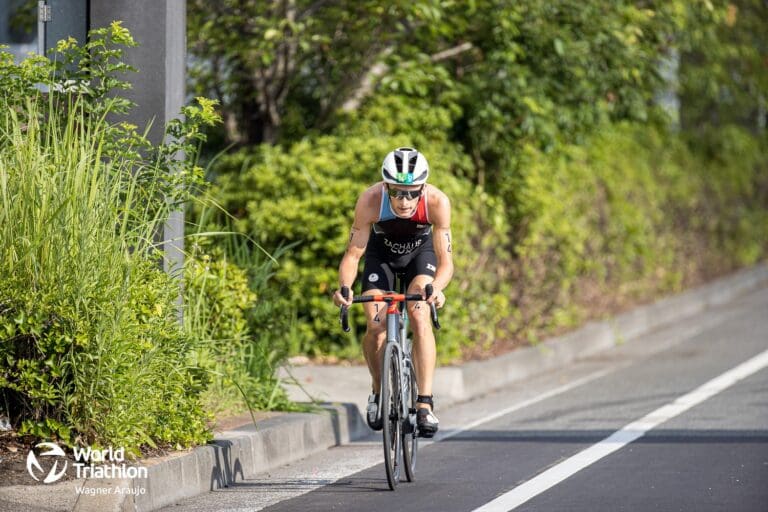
[0,101,208,451]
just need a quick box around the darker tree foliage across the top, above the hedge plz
[189,0,766,160]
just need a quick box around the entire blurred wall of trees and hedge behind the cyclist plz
[190,0,768,368]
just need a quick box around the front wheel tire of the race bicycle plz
[381,344,402,491]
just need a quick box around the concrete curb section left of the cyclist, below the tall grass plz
[73,404,368,512]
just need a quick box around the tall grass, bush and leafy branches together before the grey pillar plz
[0,23,215,453]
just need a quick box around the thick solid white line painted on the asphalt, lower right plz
[473,350,768,512]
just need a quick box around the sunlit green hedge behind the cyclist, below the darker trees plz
[206,114,768,363]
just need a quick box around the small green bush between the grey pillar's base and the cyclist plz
[184,233,293,416]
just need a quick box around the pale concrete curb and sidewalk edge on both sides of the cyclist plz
[0,264,768,512]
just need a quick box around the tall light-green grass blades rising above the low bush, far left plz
[0,99,160,297]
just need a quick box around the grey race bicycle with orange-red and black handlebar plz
[340,274,440,491]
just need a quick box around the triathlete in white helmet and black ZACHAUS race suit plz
[333,147,453,437]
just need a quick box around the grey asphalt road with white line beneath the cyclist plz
[165,290,768,512]
